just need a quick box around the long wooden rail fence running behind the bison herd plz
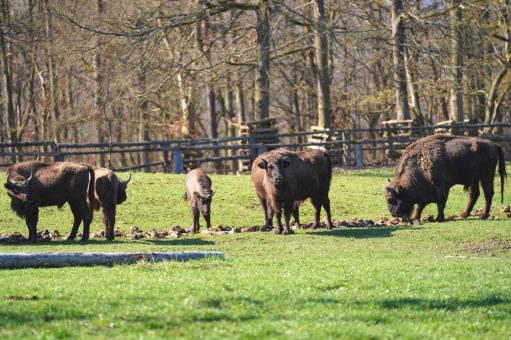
[0,124,511,174]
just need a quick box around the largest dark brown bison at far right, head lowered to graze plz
[384,135,506,222]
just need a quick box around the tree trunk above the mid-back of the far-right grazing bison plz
[450,0,465,122]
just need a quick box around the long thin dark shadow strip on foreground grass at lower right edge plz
[380,296,511,311]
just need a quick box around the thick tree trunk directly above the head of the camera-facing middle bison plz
[254,0,271,120]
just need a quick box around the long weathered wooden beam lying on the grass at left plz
[0,251,224,269]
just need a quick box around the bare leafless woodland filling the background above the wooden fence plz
[0,0,511,143]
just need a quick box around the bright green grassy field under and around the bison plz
[0,169,511,339]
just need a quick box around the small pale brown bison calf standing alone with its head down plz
[184,169,215,233]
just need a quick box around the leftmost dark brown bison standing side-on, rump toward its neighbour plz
[5,161,94,242]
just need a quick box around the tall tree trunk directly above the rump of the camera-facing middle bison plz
[314,0,331,128]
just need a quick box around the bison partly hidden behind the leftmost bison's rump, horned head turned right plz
[94,168,131,241]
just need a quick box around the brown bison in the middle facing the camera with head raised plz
[257,150,332,234]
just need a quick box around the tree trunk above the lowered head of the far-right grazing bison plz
[392,0,410,120]
